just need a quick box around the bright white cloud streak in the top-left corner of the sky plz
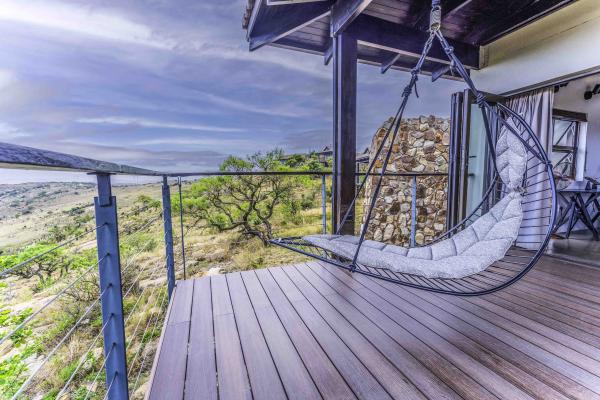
[0,0,174,49]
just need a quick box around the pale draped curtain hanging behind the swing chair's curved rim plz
[506,88,554,249]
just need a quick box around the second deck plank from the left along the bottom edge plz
[184,279,218,400]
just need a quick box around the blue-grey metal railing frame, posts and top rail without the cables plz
[0,143,447,400]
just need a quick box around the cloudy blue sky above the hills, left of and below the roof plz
[0,0,462,181]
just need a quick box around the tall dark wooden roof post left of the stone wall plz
[332,32,357,235]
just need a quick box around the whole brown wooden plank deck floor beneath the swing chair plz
[148,258,600,400]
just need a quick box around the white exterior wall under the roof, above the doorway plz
[471,0,600,94]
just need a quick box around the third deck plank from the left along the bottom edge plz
[211,275,252,400]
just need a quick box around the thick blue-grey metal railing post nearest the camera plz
[94,173,129,400]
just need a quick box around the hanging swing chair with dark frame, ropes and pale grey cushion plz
[271,0,556,296]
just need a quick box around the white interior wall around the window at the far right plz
[554,74,600,178]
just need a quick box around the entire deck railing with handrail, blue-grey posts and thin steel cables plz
[0,142,448,397]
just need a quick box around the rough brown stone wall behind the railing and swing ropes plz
[363,116,450,246]
